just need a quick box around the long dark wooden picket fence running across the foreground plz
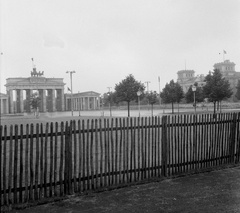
[0,113,240,205]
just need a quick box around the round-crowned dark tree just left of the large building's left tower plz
[160,80,184,113]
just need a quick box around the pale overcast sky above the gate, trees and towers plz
[0,0,240,93]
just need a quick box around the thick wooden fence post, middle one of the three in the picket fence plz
[162,116,167,177]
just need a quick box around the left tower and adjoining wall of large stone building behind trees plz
[177,70,205,93]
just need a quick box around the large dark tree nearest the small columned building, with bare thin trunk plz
[115,74,145,117]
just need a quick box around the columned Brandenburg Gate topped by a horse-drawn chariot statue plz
[5,68,65,113]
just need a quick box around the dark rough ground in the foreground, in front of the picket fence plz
[8,166,240,213]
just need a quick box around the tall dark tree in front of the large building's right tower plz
[203,69,232,115]
